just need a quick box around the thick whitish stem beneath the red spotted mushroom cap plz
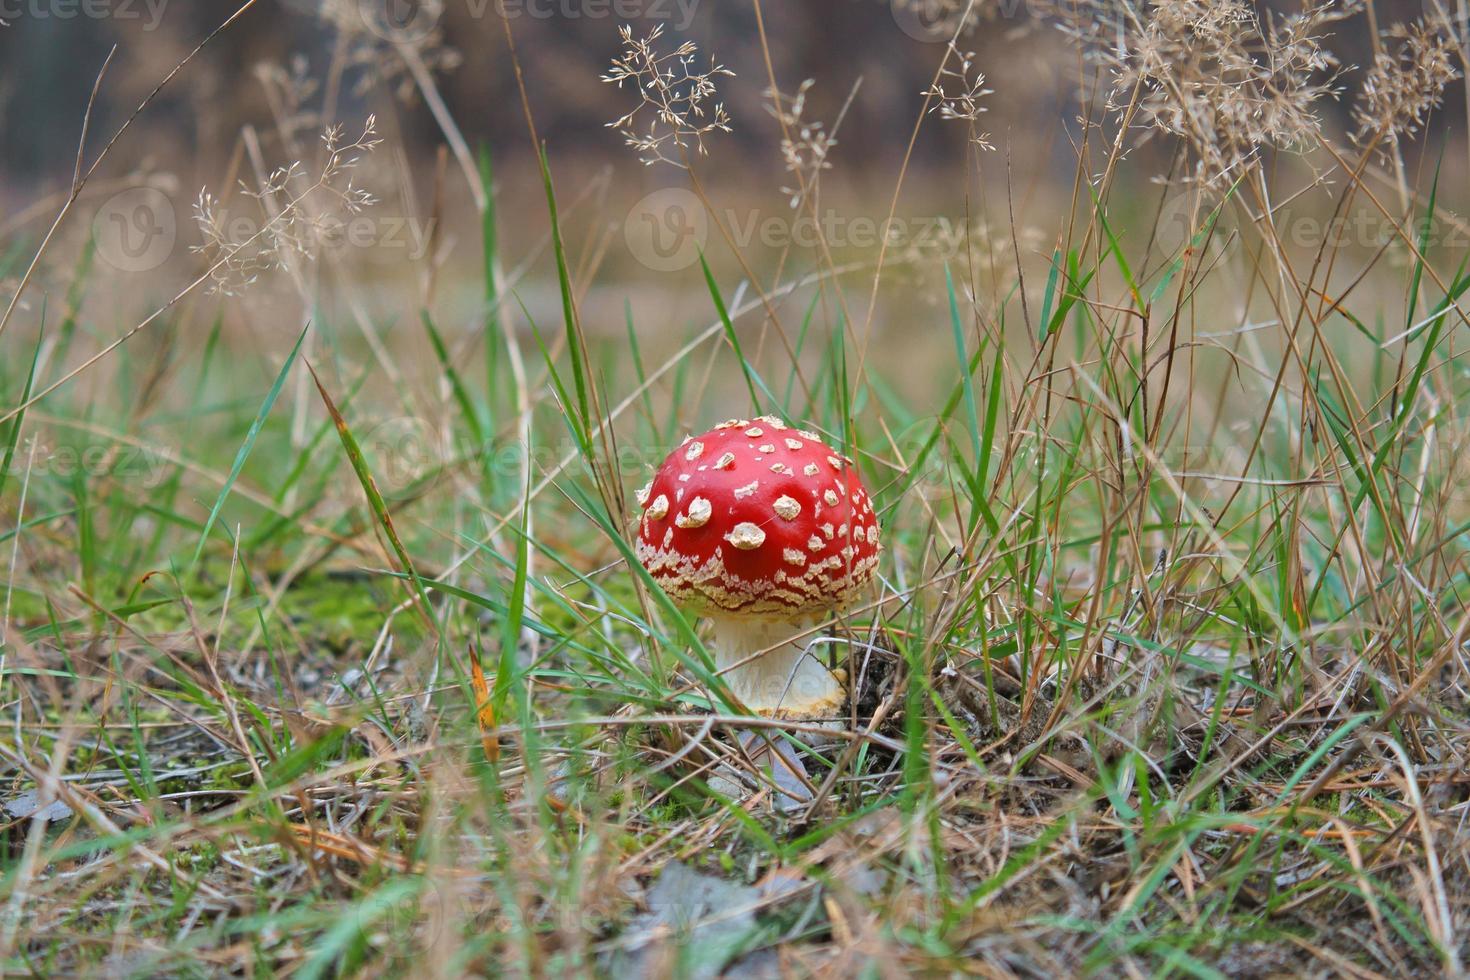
[710,614,844,718]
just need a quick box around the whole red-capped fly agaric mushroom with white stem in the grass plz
[638,416,879,717]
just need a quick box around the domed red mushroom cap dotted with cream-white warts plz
[638,416,879,619]
